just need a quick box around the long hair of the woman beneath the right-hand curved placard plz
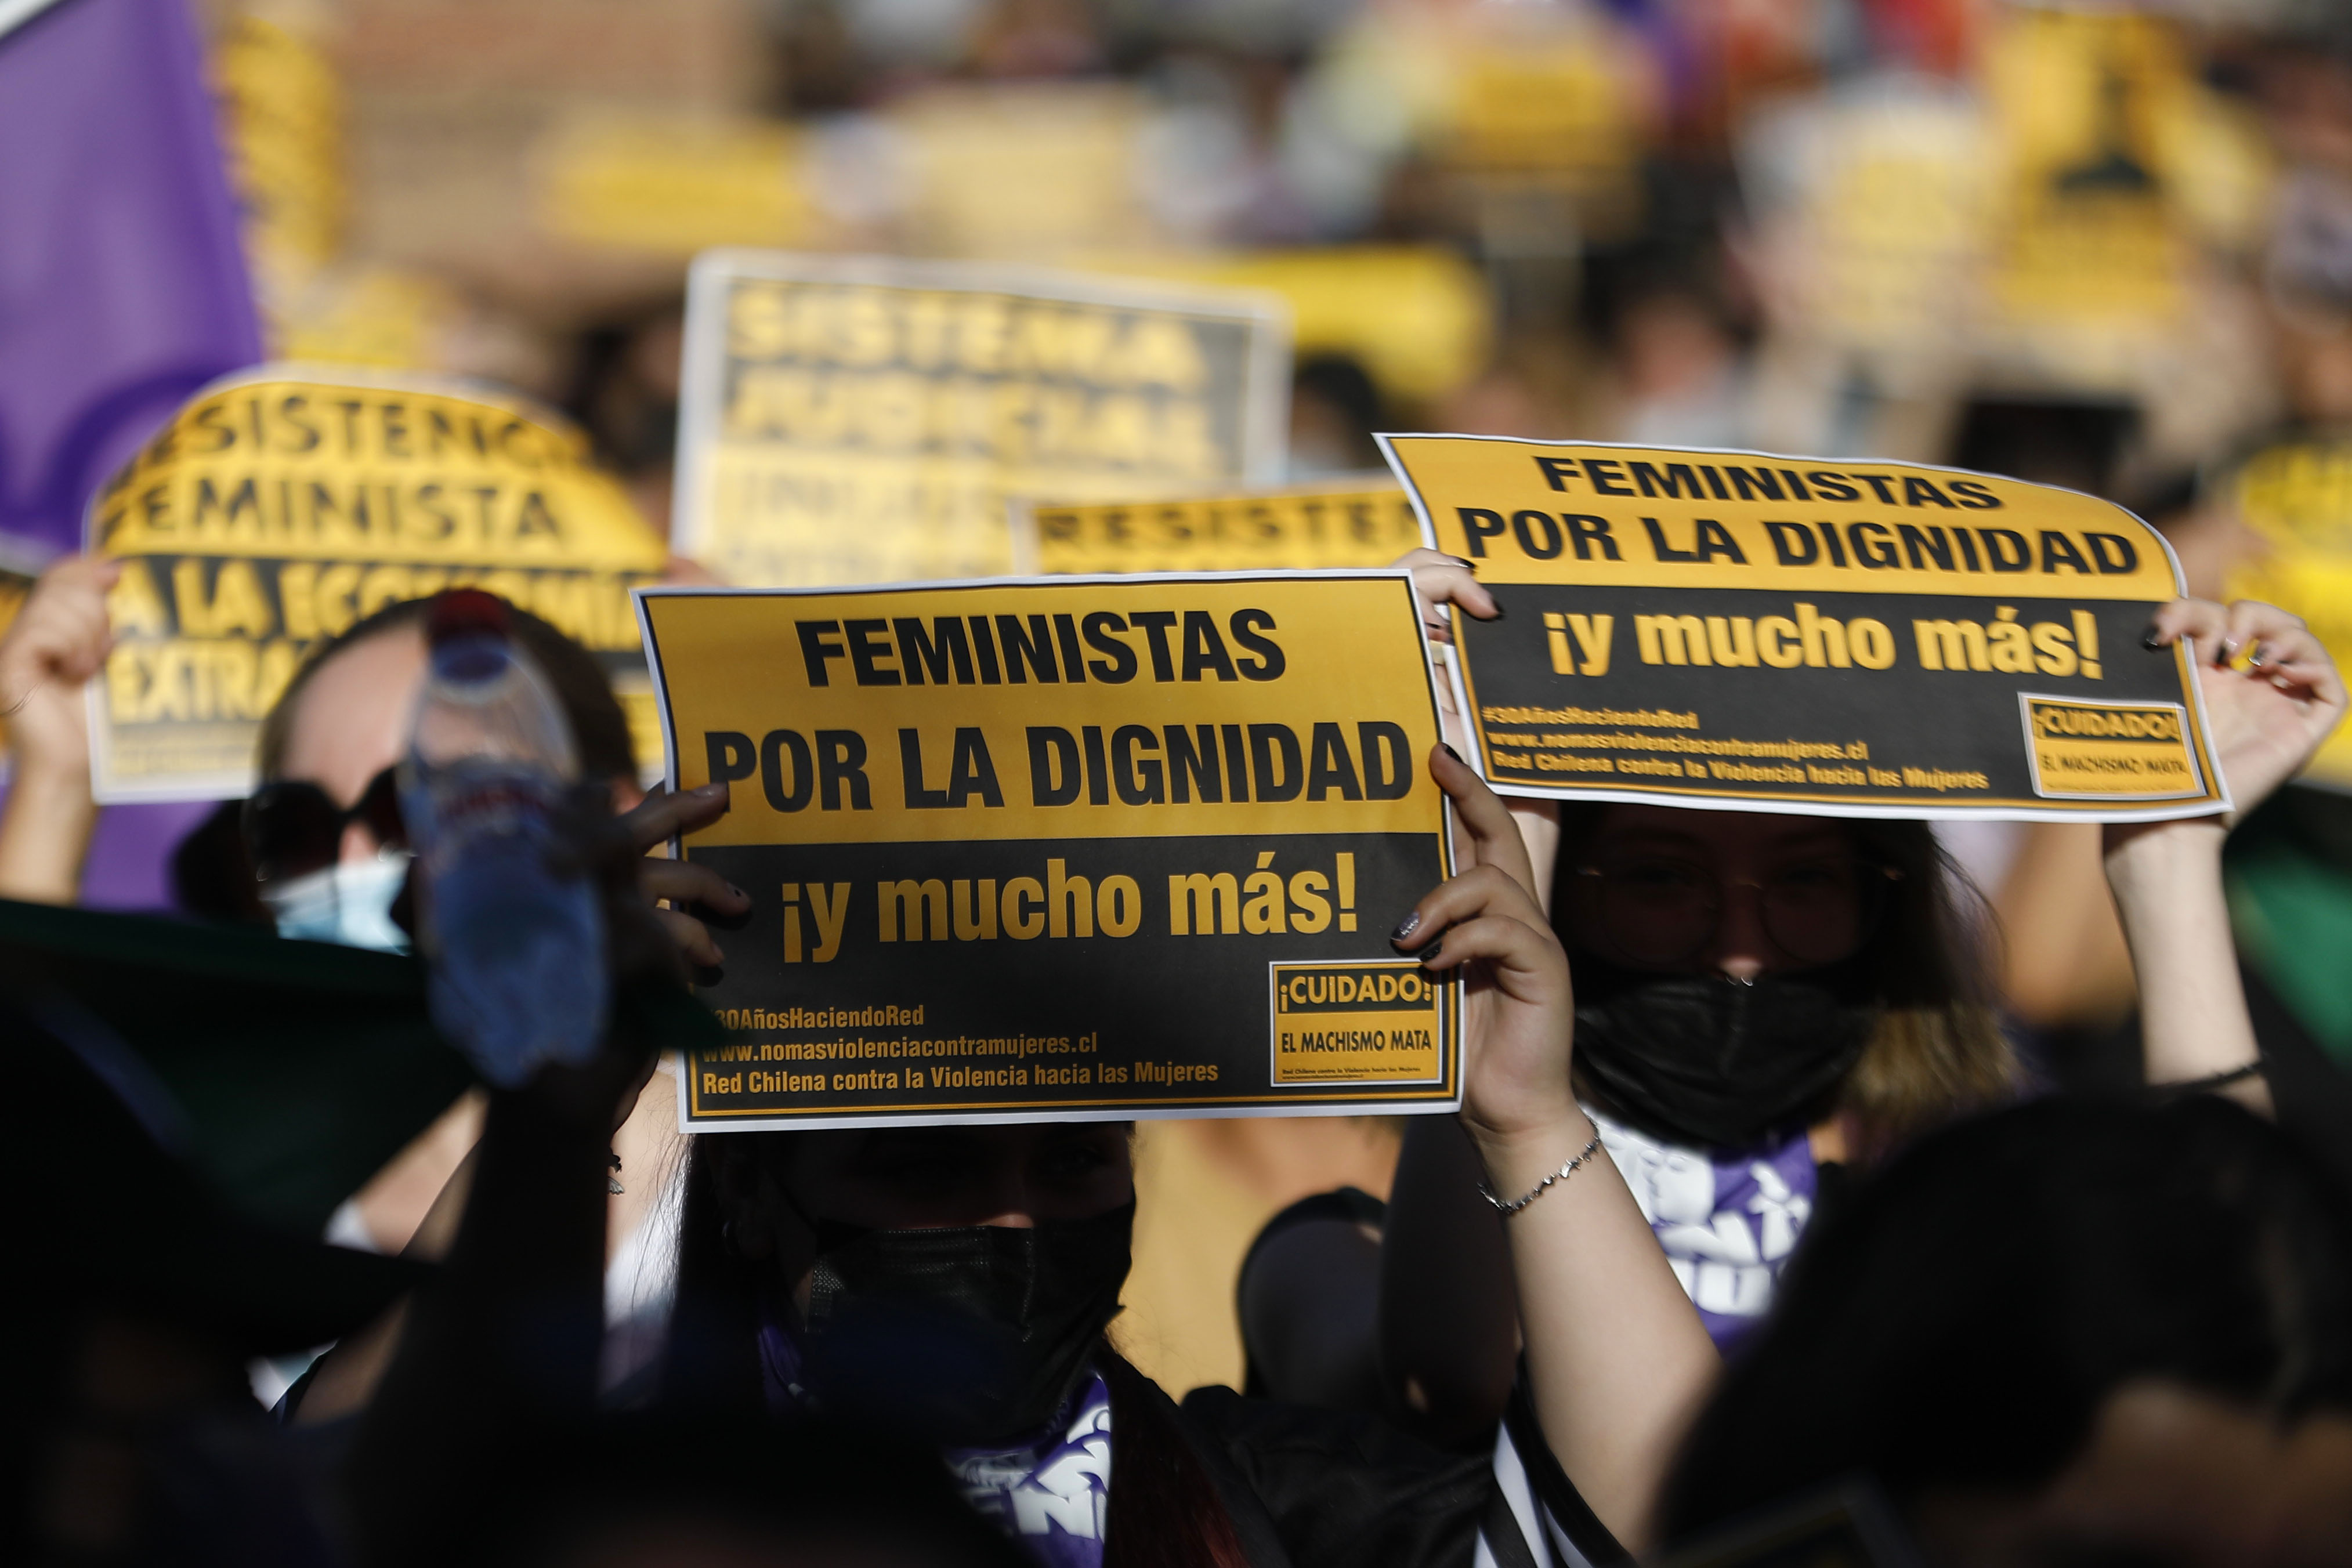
[1553,804,2022,1159]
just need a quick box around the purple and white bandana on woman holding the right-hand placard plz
[1587,1112,1821,1354]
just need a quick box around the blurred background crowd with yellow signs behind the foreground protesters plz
[13,0,2352,1523]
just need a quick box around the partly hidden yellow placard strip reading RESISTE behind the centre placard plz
[1014,473,1421,576]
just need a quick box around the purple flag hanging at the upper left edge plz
[0,0,261,907]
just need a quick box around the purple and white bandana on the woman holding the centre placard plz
[759,1307,1110,1568]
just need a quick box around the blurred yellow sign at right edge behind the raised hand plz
[2227,440,2352,788]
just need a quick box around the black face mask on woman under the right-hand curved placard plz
[1576,954,1879,1150]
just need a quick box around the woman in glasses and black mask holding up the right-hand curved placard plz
[1366,557,2345,1443]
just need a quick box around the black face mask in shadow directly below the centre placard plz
[802,1201,1136,1446]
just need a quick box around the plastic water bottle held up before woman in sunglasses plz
[400,590,611,1088]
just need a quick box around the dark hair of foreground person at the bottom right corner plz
[1660,1095,2352,1540]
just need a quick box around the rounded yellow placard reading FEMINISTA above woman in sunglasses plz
[87,364,668,802]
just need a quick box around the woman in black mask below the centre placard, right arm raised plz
[663,752,1707,1568]
